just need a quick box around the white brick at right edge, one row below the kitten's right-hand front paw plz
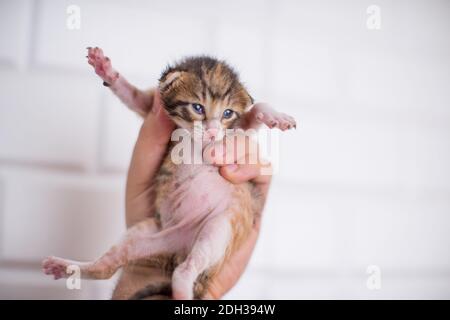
[257,180,450,270]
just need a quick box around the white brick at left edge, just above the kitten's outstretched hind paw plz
[1,168,125,262]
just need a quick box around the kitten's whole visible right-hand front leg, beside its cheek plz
[242,103,297,131]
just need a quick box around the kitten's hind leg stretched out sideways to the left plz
[42,218,183,279]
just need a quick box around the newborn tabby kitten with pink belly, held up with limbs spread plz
[43,48,295,299]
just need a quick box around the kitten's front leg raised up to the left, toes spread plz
[87,47,154,117]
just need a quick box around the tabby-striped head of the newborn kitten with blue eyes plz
[159,56,253,140]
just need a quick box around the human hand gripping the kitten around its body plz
[114,92,270,299]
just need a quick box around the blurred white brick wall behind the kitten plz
[0,0,450,299]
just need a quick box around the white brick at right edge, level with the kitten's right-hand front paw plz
[273,98,450,189]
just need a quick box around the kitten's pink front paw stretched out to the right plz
[252,103,297,131]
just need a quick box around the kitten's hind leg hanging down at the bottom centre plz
[172,216,232,299]
